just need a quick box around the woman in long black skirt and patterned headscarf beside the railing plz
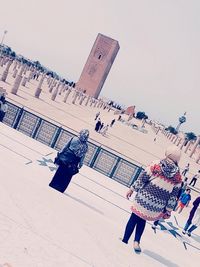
[49,129,89,193]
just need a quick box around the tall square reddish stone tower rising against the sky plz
[76,33,120,98]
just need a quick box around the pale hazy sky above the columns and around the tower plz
[0,0,200,135]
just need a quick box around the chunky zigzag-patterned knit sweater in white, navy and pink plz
[131,159,181,221]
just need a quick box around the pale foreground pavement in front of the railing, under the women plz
[0,124,200,267]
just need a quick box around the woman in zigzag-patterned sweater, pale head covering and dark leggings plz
[122,145,182,253]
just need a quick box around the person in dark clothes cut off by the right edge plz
[182,197,200,236]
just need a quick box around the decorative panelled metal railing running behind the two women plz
[3,101,143,186]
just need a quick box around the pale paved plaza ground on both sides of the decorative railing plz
[0,58,200,267]
